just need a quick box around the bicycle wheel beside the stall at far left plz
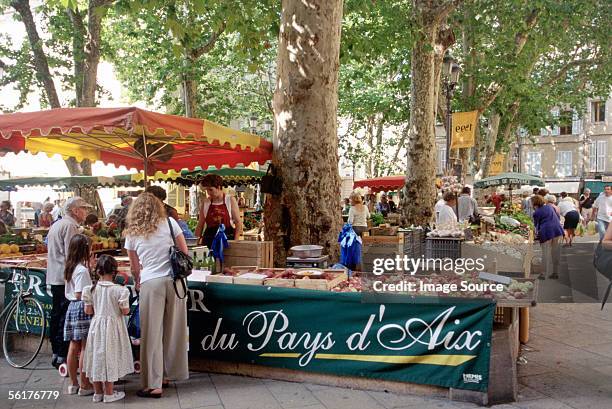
[2,297,46,368]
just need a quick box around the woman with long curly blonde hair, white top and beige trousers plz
[123,193,189,398]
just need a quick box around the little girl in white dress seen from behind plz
[83,255,134,403]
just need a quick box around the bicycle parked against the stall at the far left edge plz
[0,268,47,368]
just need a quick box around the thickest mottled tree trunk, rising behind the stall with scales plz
[265,0,342,265]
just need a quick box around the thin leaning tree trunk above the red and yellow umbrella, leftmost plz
[11,0,60,108]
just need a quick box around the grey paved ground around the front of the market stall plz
[0,234,612,409]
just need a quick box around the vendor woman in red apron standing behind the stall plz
[195,175,242,248]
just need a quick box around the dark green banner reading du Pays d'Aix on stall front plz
[188,283,495,392]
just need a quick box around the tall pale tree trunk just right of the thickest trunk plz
[402,0,455,225]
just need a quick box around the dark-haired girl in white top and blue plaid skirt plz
[64,234,94,396]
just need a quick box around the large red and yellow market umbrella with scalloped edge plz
[0,107,272,182]
